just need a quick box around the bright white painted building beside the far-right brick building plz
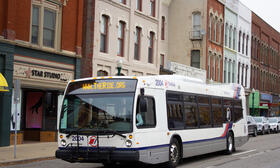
[223,0,252,88]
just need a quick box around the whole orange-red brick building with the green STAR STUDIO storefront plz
[0,0,83,146]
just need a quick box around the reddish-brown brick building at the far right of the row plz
[250,12,280,116]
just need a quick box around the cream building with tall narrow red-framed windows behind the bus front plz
[93,0,168,76]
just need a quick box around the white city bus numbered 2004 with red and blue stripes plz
[56,75,248,167]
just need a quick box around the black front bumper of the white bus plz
[55,147,139,163]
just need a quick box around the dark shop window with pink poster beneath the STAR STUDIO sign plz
[22,89,60,142]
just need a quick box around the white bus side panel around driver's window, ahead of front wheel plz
[134,88,170,164]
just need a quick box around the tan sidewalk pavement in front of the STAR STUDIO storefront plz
[0,142,58,167]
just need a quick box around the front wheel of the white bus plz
[168,138,181,168]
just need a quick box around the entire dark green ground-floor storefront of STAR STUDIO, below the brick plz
[0,43,80,146]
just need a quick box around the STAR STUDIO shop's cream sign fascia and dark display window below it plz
[11,55,78,143]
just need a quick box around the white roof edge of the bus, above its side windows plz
[71,75,245,98]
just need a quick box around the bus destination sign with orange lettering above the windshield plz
[66,79,137,95]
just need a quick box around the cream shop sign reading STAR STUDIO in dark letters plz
[14,63,74,83]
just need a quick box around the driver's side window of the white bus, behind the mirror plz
[136,97,156,128]
